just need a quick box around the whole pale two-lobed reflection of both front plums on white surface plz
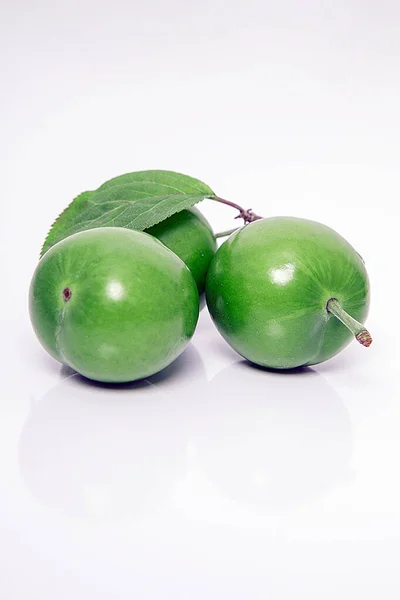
[19,347,353,520]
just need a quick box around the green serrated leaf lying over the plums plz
[41,171,215,256]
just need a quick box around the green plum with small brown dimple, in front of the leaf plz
[29,227,199,382]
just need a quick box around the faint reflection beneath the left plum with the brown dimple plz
[19,346,204,520]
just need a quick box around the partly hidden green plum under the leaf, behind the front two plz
[146,208,217,293]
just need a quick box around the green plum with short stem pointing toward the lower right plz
[206,217,372,369]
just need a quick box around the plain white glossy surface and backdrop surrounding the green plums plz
[0,0,400,600]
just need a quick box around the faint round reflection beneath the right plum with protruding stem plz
[194,362,353,511]
